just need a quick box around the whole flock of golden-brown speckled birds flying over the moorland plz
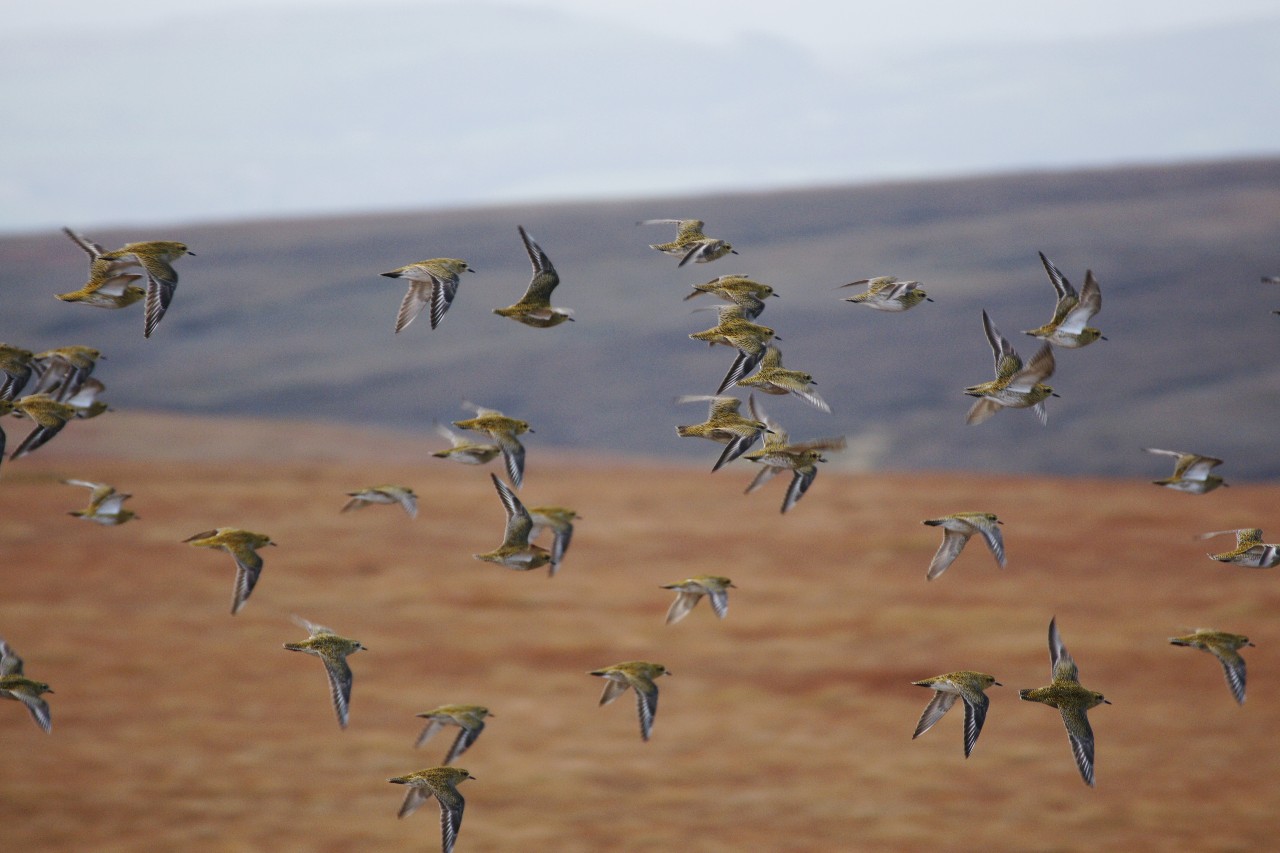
[0,219,1280,853]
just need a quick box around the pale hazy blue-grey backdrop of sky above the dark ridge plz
[0,0,1280,232]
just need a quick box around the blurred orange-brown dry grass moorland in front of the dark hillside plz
[0,414,1280,853]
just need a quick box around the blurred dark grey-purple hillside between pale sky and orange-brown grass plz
[0,160,1280,480]
